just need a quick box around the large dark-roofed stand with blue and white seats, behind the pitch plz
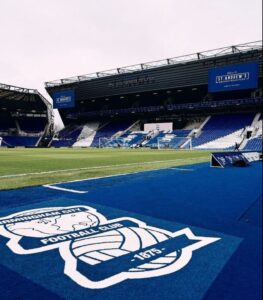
[45,42,263,150]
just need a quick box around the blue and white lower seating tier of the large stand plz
[51,113,262,150]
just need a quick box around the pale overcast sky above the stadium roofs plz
[0,0,262,97]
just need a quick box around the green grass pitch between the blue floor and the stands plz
[0,148,211,190]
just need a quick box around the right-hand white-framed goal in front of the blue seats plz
[158,136,193,150]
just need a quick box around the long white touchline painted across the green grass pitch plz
[0,156,207,178]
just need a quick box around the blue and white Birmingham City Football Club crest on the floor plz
[0,205,220,289]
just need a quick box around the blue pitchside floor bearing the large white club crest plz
[0,163,262,300]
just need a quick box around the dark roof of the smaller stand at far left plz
[0,83,51,112]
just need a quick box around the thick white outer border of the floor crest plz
[0,205,220,289]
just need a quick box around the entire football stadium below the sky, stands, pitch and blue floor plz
[0,1,263,300]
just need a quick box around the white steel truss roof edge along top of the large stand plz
[45,40,262,88]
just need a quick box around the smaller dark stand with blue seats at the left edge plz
[0,84,53,147]
